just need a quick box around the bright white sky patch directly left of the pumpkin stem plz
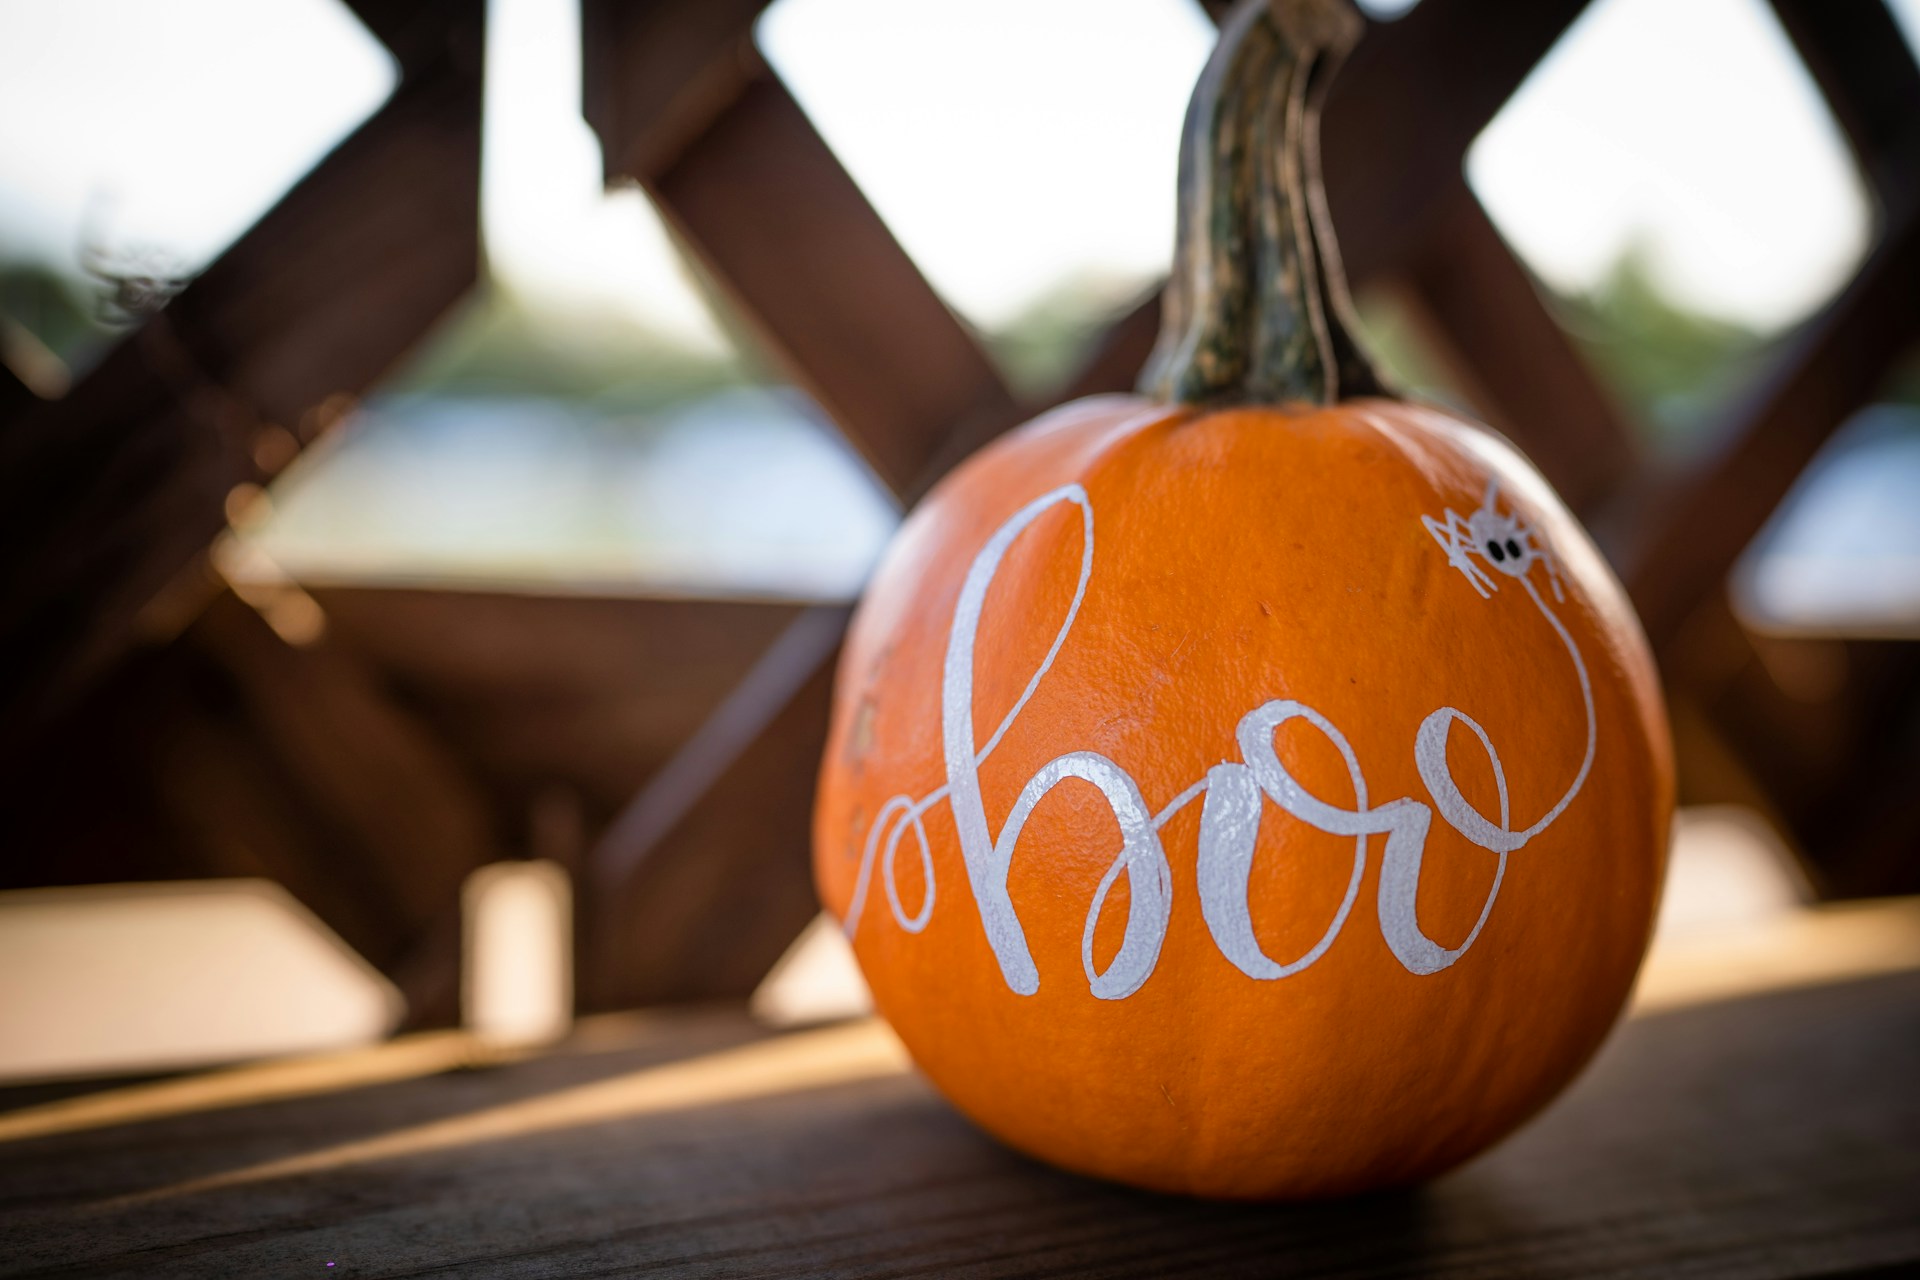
[760,0,1213,326]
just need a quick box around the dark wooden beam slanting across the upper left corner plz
[0,27,480,743]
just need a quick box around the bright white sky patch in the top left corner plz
[0,0,394,273]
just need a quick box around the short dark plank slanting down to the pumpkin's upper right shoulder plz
[1402,173,1640,512]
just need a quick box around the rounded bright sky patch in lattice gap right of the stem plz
[1467,0,1870,328]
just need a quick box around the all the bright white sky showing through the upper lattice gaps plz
[0,0,1920,344]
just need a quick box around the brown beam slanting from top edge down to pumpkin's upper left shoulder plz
[584,0,1018,495]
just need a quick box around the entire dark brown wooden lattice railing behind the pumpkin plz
[0,0,1920,1025]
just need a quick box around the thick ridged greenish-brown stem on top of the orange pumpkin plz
[1140,0,1384,405]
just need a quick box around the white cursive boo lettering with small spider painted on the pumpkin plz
[845,482,1596,1000]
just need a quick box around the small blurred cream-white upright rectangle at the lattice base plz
[461,860,574,1048]
